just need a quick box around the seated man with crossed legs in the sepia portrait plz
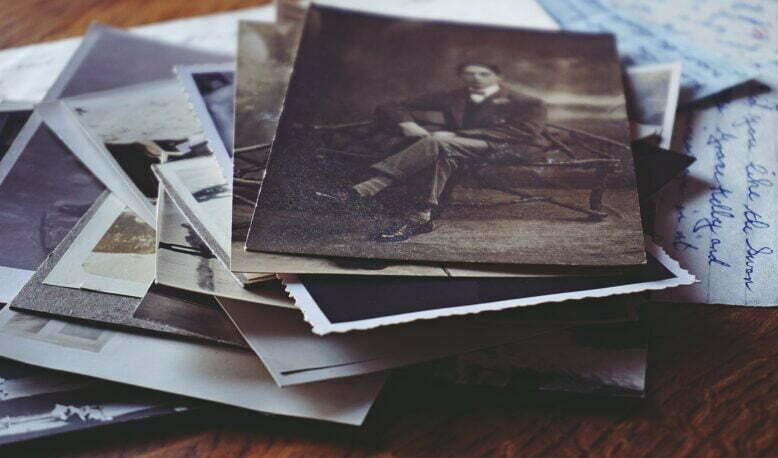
[317,61,548,242]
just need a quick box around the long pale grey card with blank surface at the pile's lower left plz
[0,308,385,425]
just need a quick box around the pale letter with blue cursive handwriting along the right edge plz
[608,0,778,306]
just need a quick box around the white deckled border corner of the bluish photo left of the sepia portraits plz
[174,64,235,181]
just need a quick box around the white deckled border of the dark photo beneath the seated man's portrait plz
[278,239,697,335]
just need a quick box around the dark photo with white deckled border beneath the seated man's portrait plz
[279,240,696,335]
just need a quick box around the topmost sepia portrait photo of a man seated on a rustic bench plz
[247,6,646,266]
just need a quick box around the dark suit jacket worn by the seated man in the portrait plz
[376,87,547,147]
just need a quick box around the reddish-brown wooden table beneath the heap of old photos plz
[0,0,778,457]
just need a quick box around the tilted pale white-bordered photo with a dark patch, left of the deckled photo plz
[39,78,211,225]
